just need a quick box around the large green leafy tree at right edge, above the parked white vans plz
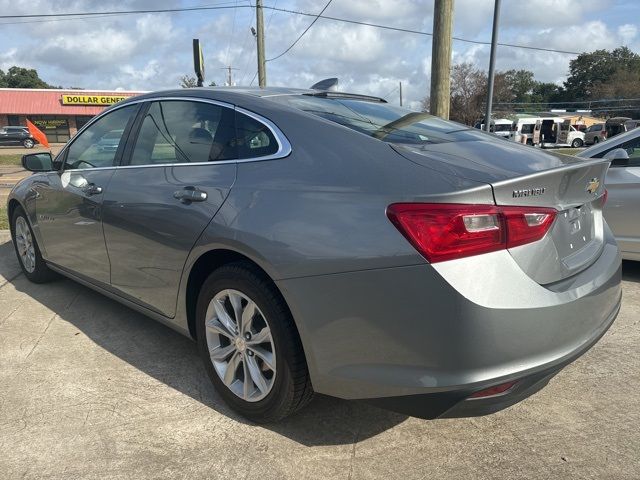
[564,47,640,100]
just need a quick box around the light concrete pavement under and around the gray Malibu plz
[0,233,640,480]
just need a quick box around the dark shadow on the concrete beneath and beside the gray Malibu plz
[0,243,407,446]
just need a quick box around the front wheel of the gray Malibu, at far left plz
[11,207,56,283]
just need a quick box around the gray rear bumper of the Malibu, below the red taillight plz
[278,226,621,418]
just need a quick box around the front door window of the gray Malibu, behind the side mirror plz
[64,105,138,170]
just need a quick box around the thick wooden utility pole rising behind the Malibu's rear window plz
[429,0,453,120]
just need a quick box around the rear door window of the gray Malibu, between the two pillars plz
[130,100,237,165]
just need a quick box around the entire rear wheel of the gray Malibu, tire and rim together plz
[196,262,313,423]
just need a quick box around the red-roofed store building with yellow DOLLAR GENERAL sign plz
[0,88,145,143]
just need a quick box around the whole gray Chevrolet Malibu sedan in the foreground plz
[8,88,621,421]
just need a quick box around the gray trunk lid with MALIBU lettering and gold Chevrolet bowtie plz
[394,141,609,285]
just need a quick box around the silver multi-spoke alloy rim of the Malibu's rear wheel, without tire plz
[205,289,276,402]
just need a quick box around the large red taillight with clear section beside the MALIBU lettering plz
[387,203,557,263]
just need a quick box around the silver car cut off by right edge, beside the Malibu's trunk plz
[577,125,640,260]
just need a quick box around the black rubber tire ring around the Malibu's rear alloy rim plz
[196,267,293,421]
